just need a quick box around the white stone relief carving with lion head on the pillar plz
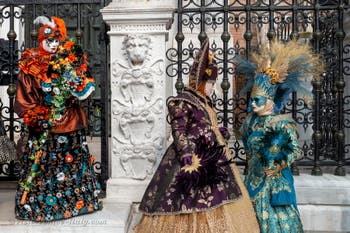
[112,34,165,180]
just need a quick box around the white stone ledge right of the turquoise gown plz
[294,173,350,233]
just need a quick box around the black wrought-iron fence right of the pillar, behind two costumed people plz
[167,0,350,176]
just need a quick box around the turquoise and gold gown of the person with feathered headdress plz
[242,113,303,233]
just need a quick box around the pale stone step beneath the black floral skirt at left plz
[0,189,130,233]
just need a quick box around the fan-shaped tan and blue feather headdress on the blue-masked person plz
[236,40,323,112]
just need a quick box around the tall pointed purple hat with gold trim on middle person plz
[189,38,218,90]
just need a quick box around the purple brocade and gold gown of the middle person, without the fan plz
[135,88,259,233]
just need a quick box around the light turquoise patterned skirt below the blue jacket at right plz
[253,179,304,233]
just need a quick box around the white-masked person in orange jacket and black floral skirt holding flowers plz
[14,16,101,222]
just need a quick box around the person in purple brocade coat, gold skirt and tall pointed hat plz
[135,39,260,233]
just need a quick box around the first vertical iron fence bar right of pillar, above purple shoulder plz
[175,0,185,94]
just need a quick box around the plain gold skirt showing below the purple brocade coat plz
[134,164,260,233]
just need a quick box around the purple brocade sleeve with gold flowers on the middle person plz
[168,100,195,159]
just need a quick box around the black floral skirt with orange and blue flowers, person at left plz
[15,130,100,222]
